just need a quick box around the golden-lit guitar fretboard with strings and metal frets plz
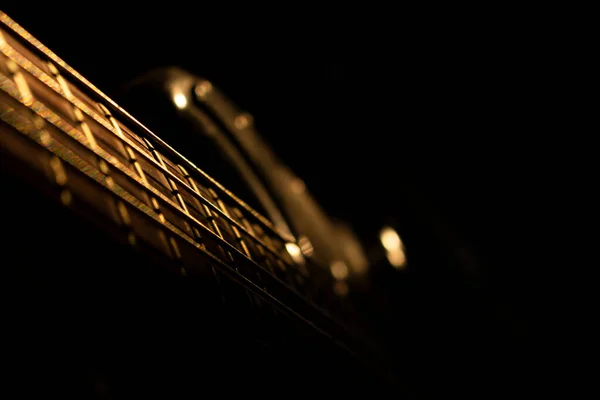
[0,12,390,378]
